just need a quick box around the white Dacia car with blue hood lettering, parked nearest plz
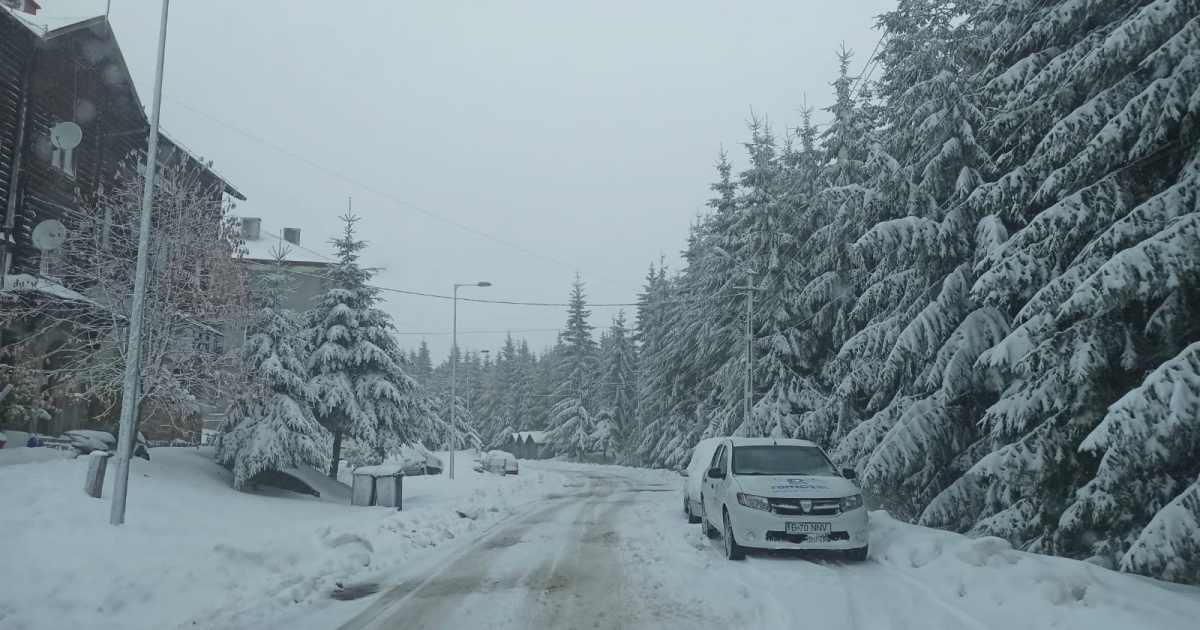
[701,438,868,560]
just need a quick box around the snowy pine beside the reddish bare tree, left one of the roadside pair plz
[215,250,330,488]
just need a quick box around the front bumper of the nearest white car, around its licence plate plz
[730,505,870,550]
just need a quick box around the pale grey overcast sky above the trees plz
[87,0,895,358]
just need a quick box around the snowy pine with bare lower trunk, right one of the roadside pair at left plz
[307,214,434,479]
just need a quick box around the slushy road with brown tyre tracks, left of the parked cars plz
[342,472,657,630]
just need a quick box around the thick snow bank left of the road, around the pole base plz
[0,448,563,630]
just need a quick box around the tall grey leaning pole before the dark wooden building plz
[108,0,170,526]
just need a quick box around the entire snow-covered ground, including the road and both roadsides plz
[0,449,1200,630]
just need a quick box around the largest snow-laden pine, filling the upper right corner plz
[923,0,1200,575]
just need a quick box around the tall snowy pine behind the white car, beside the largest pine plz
[820,0,1008,517]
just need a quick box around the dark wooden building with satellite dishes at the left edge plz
[0,0,245,433]
